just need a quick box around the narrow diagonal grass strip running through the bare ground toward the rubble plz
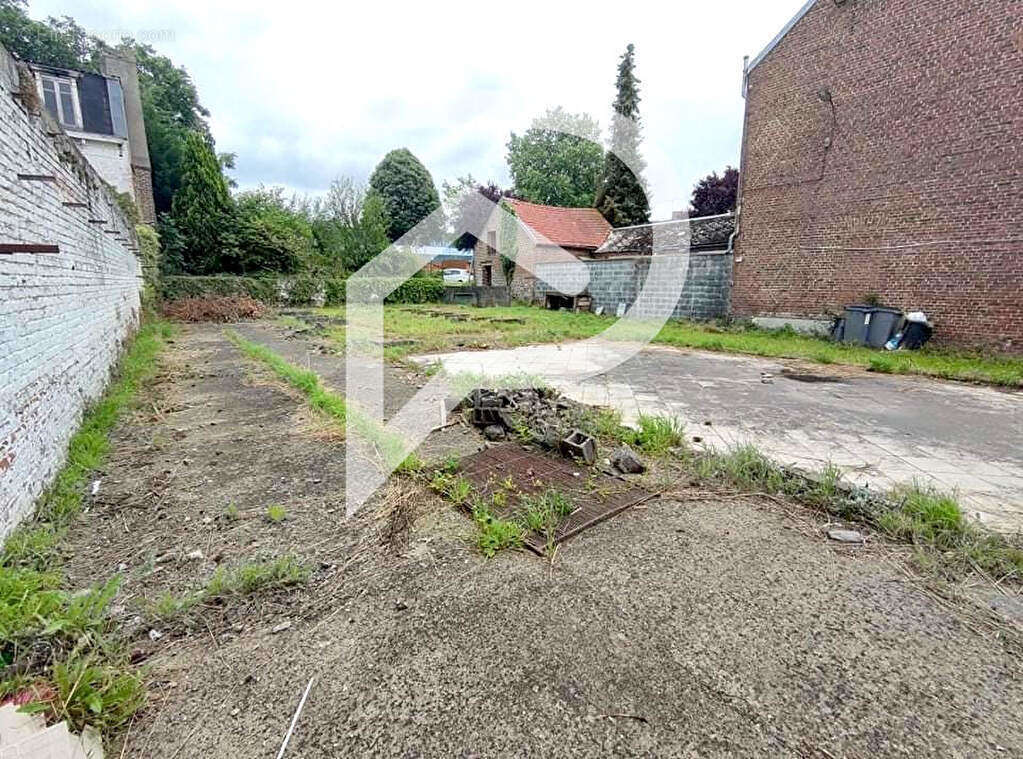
[225,329,424,473]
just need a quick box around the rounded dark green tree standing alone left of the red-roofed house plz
[369,147,441,240]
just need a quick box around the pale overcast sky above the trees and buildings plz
[30,0,803,218]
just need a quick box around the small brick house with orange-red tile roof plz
[474,198,611,301]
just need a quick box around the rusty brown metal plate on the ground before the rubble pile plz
[458,443,656,555]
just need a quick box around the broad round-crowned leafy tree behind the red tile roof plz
[507,107,604,208]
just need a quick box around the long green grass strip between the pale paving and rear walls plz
[322,305,1023,388]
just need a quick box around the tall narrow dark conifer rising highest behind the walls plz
[594,44,650,227]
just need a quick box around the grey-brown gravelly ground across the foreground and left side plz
[61,323,1023,759]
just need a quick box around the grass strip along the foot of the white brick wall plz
[0,321,173,731]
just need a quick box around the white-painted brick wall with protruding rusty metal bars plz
[0,47,141,536]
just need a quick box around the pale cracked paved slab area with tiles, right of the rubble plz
[416,342,1023,532]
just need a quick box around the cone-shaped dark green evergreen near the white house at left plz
[171,132,234,274]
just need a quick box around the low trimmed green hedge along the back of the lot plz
[161,274,444,306]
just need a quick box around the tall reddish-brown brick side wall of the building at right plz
[732,0,1023,351]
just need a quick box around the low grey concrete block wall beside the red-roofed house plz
[537,251,731,319]
